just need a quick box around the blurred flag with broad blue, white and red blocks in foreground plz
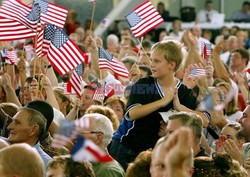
[71,136,113,162]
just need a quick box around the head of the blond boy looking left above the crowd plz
[151,41,183,79]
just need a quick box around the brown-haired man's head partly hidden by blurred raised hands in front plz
[167,112,202,144]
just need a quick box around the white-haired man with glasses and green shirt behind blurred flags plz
[81,114,125,177]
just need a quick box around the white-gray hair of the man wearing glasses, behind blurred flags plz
[82,113,114,147]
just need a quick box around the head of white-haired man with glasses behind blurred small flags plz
[81,113,114,149]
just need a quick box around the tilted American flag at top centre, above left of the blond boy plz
[125,0,164,38]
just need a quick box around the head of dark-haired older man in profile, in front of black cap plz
[8,107,46,146]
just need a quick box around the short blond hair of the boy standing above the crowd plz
[152,41,183,71]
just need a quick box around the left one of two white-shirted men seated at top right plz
[197,0,218,23]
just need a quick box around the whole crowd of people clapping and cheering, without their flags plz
[0,1,250,177]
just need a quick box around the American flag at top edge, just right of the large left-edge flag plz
[34,0,68,29]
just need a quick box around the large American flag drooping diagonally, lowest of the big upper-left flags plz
[43,24,85,75]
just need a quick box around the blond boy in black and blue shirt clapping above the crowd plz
[110,41,208,169]
